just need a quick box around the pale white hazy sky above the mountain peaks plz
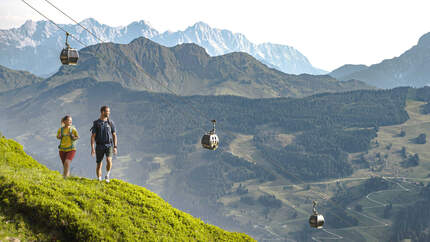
[0,0,430,71]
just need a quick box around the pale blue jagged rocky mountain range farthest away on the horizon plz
[0,18,327,77]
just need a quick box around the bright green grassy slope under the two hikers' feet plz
[0,138,253,241]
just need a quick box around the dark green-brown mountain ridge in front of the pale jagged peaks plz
[36,37,371,98]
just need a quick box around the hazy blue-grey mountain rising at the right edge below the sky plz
[329,33,430,88]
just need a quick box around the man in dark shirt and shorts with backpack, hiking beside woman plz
[91,106,117,182]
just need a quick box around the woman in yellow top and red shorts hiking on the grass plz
[57,115,79,178]
